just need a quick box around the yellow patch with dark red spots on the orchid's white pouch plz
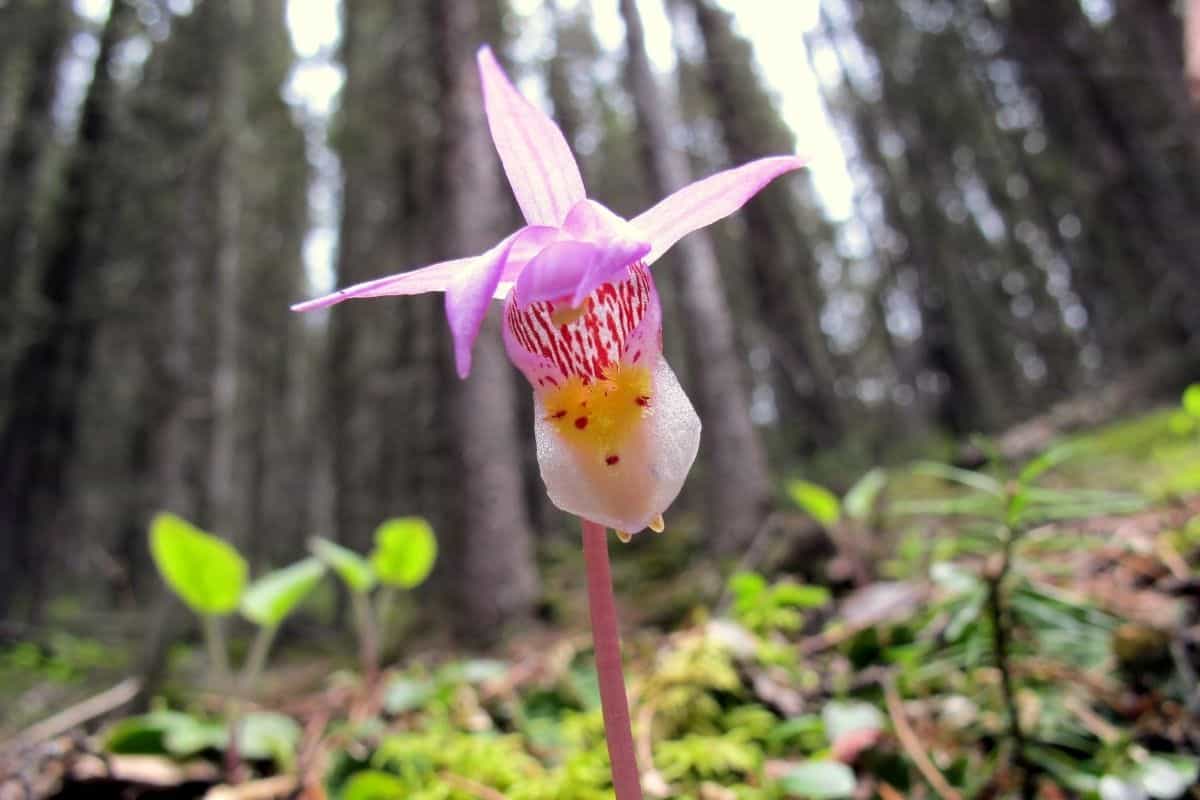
[542,365,652,469]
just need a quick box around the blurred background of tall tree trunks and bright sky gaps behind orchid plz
[0,0,1200,796]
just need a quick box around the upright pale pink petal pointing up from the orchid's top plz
[476,46,584,225]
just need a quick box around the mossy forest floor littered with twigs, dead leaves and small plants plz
[0,409,1200,800]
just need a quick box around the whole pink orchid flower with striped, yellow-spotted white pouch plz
[293,47,804,540]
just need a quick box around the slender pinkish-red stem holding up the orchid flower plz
[583,519,642,800]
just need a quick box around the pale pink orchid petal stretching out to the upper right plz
[631,156,805,264]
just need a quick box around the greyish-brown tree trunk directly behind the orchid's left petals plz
[434,0,538,644]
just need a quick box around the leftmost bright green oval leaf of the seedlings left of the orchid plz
[150,513,246,614]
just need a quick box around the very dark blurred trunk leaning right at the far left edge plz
[0,0,133,618]
